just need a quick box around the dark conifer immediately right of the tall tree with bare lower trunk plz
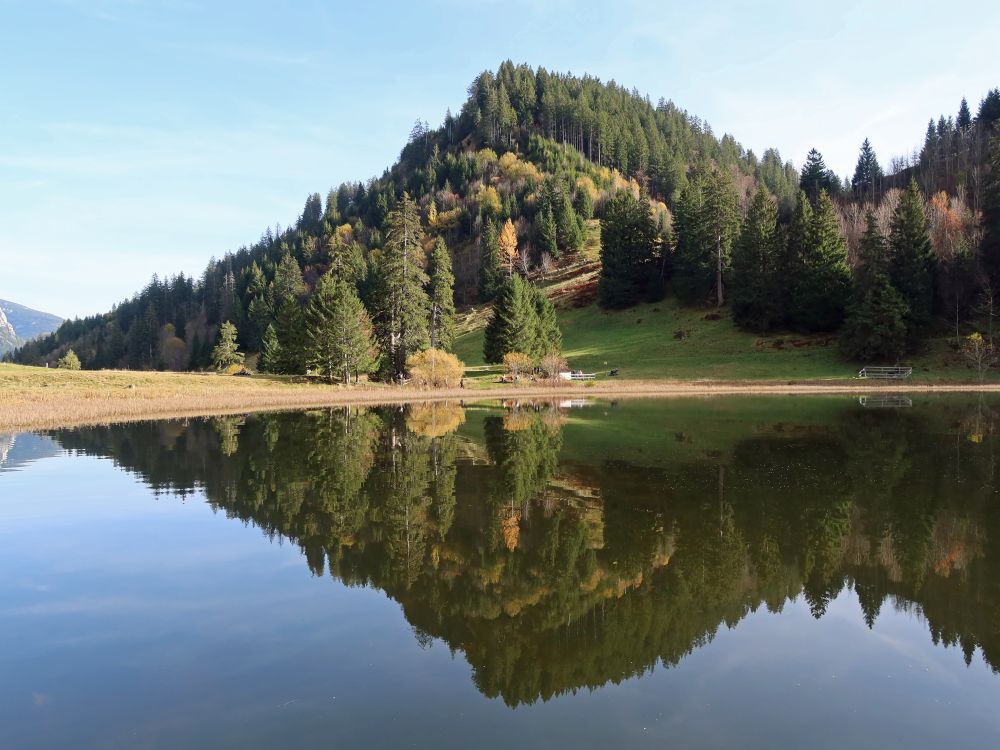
[733,185,782,333]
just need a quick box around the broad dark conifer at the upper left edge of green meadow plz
[597,190,658,308]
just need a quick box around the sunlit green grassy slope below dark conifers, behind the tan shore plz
[456,299,997,382]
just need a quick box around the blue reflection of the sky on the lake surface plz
[0,406,1000,748]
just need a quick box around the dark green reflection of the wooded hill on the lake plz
[45,404,1000,704]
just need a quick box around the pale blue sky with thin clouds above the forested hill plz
[0,0,1000,316]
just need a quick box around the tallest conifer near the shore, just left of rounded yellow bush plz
[376,193,429,379]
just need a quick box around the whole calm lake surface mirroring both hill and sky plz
[0,397,1000,750]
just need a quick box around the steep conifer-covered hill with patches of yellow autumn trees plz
[7,62,1000,374]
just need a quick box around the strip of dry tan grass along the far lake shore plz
[0,367,1000,432]
